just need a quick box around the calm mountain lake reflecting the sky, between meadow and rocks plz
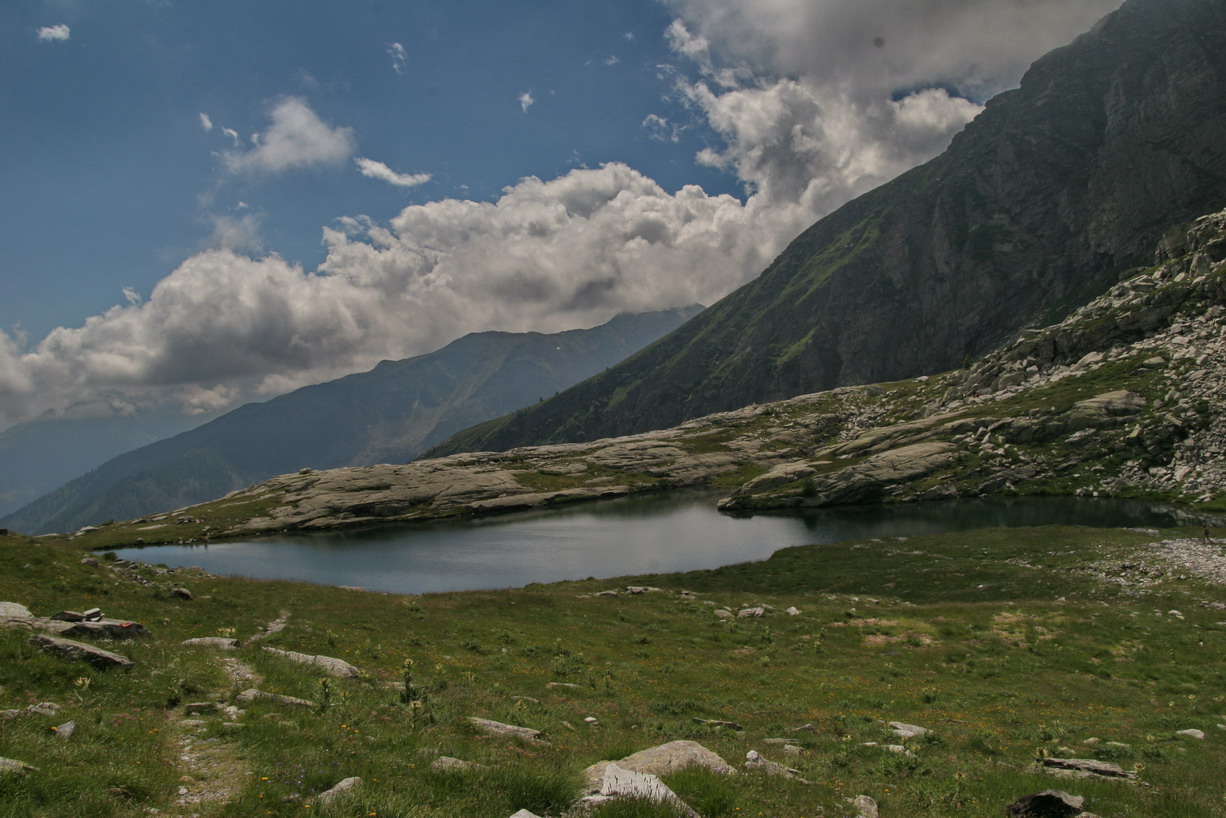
[116,492,1188,594]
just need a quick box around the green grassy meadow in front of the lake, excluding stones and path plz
[0,527,1226,818]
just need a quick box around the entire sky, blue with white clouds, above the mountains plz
[0,0,1118,429]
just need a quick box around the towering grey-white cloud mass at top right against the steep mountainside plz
[644,0,1119,217]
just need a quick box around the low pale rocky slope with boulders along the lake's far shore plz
[74,211,1226,545]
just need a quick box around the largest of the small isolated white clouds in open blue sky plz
[224,97,356,173]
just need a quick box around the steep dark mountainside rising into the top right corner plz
[429,0,1226,455]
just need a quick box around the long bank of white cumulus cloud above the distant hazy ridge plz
[0,164,787,423]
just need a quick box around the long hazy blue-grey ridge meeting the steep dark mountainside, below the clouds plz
[0,305,702,533]
